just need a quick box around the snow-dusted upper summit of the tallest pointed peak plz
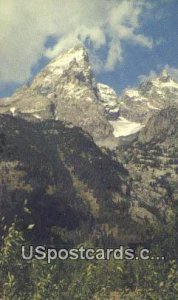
[31,44,94,95]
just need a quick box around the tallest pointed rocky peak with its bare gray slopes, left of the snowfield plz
[0,46,118,146]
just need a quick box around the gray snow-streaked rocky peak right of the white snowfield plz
[120,70,178,124]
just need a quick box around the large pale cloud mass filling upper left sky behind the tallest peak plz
[0,0,153,83]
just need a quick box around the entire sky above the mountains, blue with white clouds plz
[0,0,178,97]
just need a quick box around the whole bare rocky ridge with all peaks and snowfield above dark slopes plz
[0,46,178,148]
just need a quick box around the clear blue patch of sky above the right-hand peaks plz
[97,0,178,93]
